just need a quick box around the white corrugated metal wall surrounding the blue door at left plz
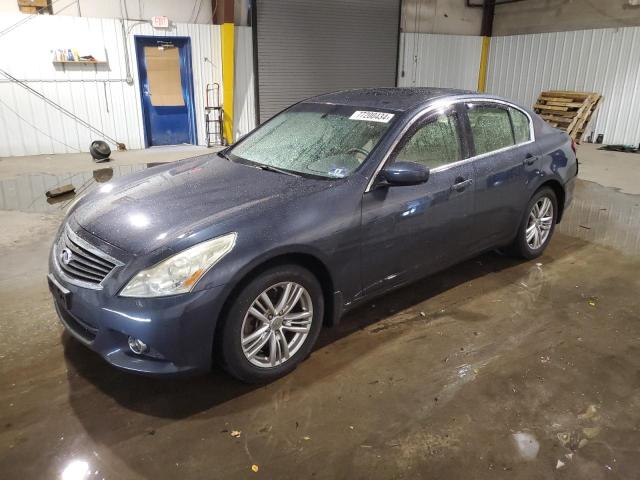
[0,14,222,156]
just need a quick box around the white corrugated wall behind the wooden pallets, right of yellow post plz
[487,27,640,145]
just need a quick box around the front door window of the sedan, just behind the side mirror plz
[396,114,462,168]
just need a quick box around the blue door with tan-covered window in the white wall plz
[135,36,197,147]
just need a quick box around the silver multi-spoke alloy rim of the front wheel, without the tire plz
[241,282,313,368]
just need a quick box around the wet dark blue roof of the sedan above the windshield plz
[304,87,476,112]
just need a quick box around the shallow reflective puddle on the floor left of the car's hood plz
[0,162,167,212]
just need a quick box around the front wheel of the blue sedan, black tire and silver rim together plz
[217,265,324,383]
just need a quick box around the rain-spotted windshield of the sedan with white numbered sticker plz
[227,103,396,178]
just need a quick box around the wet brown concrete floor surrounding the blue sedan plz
[0,144,640,479]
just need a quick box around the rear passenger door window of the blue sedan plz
[467,105,514,155]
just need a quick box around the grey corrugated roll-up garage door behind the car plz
[256,0,400,122]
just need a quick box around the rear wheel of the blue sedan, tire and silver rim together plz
[509,187,558,260]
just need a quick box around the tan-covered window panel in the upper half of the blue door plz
[144,46,184,107]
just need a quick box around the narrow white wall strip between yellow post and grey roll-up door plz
[233,26,256,139]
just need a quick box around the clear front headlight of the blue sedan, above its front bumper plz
[120,232,238,298]
